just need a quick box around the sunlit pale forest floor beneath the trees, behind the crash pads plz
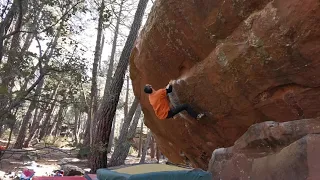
[0,141,164,180]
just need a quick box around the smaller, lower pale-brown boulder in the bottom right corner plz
[209,118,320,180]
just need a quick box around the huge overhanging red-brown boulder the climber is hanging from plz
[130,0,320,169]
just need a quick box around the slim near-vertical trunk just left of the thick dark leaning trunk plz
[85,0,105,145]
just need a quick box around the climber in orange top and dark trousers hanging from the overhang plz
[144,80,204,120]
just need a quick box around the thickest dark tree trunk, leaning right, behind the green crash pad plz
[90,0,148,172]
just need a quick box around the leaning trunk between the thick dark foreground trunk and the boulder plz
[109,105,141,166]
